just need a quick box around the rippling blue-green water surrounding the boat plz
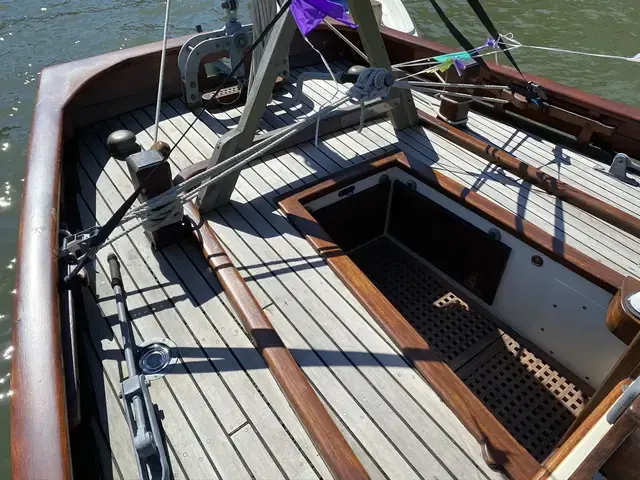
[0,0,640,478]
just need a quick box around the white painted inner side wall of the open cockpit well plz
[307,168,626,388]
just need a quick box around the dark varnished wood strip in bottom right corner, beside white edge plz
[569,398,640,480]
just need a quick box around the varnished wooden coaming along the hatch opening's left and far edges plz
[279,153,540,480]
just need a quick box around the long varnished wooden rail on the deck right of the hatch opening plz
[418,111,640,244]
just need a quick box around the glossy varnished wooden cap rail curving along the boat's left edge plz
[11,33,195,480]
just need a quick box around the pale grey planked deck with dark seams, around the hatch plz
[72,62,640,479]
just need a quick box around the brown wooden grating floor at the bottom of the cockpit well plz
[350,237,588,461]
